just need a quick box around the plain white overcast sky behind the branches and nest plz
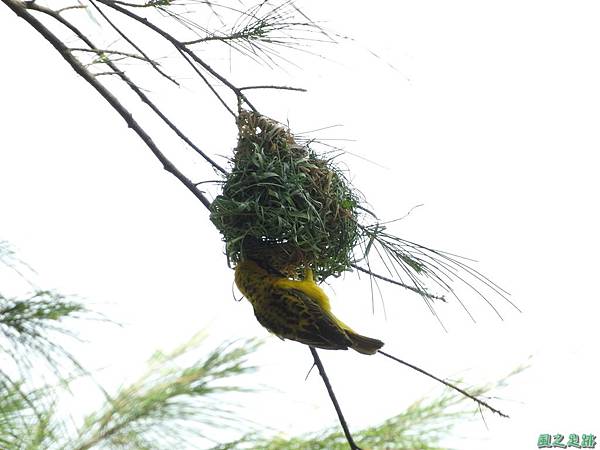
[0,0,600,450]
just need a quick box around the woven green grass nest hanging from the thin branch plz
[210,111,360,280]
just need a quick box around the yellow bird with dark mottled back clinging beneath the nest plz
[235,259,383,355]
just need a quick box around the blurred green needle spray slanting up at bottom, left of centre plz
[71,336,258,450]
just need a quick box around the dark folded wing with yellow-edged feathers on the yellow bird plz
[255,287,352,350]
